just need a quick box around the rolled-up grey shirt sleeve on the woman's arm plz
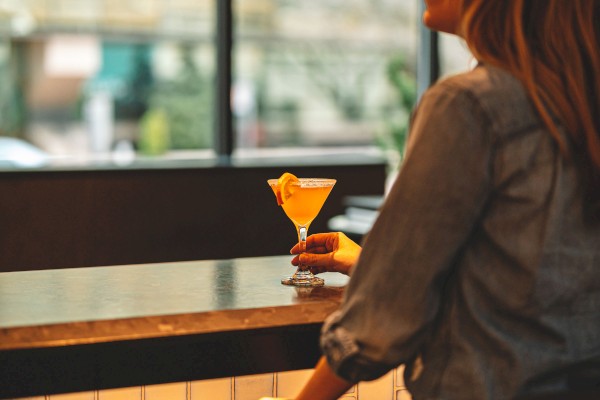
[321,78,492,382]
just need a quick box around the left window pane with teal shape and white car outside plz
[0,0,215,167]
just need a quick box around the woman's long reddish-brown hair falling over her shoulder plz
[460,0,600,218]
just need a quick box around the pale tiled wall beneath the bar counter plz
[15,367,411,400]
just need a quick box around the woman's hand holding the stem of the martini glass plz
[290,232,362,275]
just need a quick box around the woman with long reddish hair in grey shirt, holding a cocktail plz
[292,0,600,400]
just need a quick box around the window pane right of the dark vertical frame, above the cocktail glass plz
[233,0,418,155]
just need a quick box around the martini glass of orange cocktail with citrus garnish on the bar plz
[267,178,336,286]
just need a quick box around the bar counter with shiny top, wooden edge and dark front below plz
[0,256,348,398]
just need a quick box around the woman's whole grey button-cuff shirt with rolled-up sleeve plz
[321,65,600,400]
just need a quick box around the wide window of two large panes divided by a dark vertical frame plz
[0,0,420,168]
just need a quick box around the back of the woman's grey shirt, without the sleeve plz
[406,66,600,399]
